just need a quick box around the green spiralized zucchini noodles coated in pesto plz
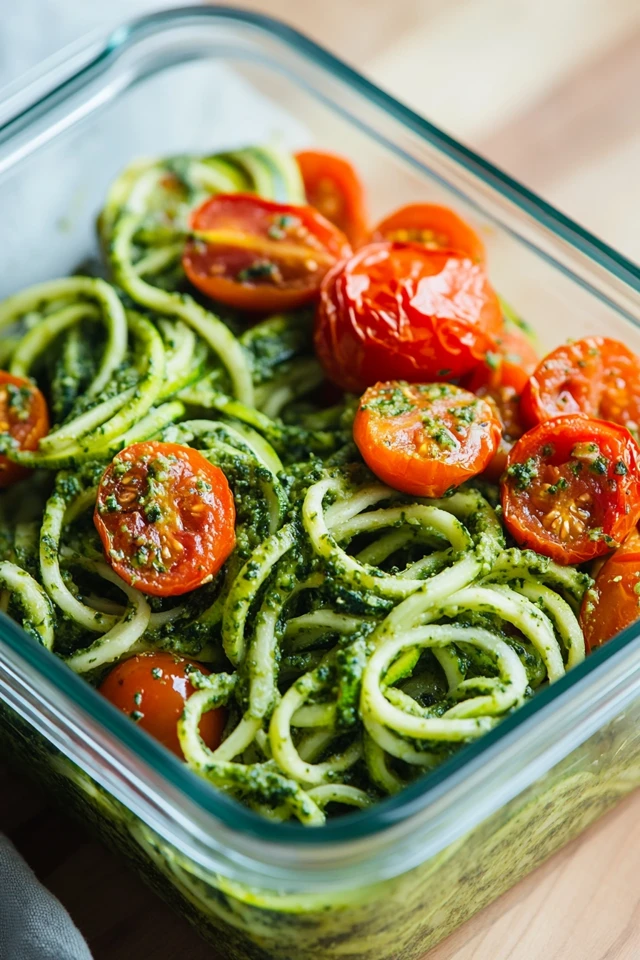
[0,142,590,825]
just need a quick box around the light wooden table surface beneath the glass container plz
[0,0,640,960]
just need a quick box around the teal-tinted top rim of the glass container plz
[0,6,640,847]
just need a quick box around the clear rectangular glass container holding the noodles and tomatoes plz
[0,7,640,960]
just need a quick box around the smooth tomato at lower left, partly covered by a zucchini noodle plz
[98,653,226,759]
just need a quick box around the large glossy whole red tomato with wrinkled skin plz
[314,243,502,393]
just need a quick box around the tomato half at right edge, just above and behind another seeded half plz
[522,337,640,430]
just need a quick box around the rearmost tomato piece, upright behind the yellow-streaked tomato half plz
[296,150,368,247]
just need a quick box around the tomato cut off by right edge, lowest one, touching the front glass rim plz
[580,528,640,651]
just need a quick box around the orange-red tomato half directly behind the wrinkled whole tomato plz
[371,203,487,263]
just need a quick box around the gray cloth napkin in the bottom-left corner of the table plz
[0,835,91,960]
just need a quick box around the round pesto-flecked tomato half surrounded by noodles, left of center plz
[94,440,235,597]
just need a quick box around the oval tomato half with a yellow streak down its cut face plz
[182,193,351,311]
